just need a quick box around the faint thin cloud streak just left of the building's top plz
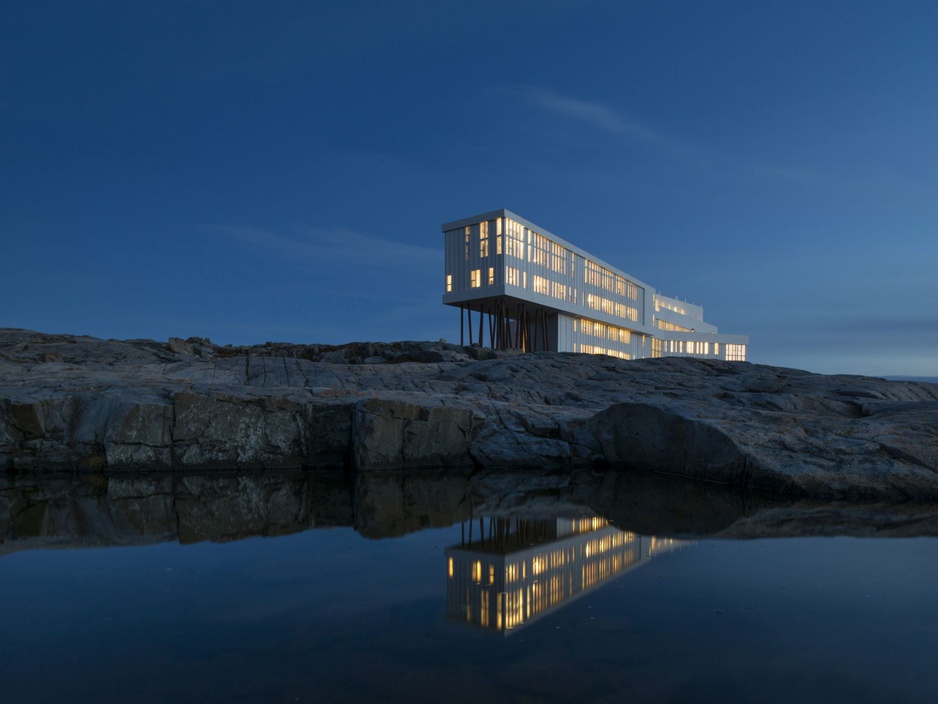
[205,225,441,267]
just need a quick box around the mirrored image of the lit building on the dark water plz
[445,517,683,634]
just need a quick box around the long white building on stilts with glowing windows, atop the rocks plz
[443,210,749,361]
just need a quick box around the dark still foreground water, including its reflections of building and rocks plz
[0,470,938,702]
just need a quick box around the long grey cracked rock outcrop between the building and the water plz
[0,330,938,500]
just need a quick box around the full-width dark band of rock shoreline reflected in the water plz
[0,470,938,554]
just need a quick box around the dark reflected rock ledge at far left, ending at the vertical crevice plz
[0,472,352,548]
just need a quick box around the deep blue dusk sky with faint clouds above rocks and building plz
[0,0,938,376]
